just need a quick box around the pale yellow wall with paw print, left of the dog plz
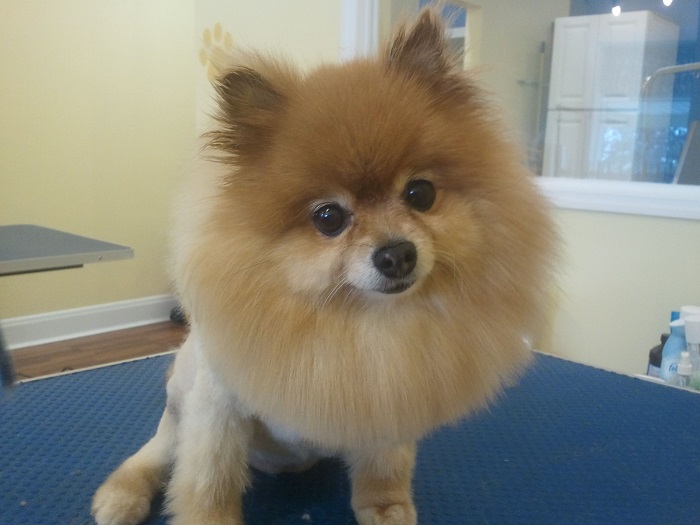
[0,0,340,319]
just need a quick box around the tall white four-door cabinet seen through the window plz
[542,11,678,180]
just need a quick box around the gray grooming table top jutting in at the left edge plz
[0,224,134,276]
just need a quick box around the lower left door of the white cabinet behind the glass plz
[542,111,589,179]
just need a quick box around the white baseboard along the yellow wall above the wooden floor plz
[0,295,177,350]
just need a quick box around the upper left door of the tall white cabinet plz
[548,16,598,109]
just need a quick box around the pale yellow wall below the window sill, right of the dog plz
[545,210,700,373]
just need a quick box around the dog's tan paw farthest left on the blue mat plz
[92,480,151,525]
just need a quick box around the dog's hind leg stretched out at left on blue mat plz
[92,407,176,525]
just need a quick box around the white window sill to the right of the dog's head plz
[537,177,700,219]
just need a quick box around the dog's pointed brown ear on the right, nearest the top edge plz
[385,8,454,79]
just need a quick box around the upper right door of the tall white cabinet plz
[593,12,648,110]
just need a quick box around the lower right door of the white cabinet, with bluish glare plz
[588,111,639,180]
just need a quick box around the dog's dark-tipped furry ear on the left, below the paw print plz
[206,61,287,161]
